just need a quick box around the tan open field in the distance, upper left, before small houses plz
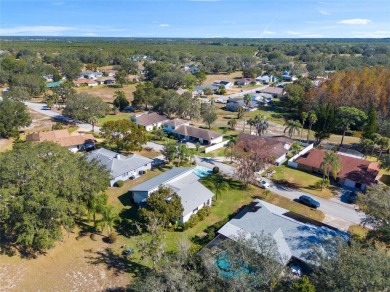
[75,84,135,103]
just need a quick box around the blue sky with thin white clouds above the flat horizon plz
[0,0,390,38]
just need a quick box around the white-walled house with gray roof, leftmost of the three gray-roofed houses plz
[87,148,153,187]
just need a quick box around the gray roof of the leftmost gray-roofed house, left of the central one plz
[88,148,153,178]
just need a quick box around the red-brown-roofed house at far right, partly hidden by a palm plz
[294,149,379,191]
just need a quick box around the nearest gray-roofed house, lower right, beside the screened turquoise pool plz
[200,199,349,266]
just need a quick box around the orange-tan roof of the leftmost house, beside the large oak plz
[26,130,95,147]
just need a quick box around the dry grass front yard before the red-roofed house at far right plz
[272,164,336,199]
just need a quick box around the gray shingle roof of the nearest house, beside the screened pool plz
[218,199,349,263]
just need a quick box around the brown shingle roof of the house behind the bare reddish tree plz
[237,133,292,159]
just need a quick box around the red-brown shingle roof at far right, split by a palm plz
[295,149,379,185]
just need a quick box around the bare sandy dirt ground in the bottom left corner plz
[0,229,130,291]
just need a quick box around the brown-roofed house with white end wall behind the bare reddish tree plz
[237,133,293,165]
